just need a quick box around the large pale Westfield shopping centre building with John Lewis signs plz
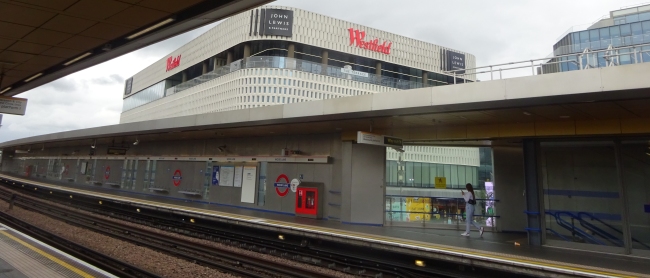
[120,6,476,123]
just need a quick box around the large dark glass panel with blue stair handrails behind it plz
[540,142,623,252]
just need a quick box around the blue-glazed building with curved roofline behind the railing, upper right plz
[543,5,650,73]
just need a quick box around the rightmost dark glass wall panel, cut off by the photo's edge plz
[621,140,650,255]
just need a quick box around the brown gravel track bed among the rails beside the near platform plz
[0,188,357,278]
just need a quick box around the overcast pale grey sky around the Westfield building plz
[0,0,647,142]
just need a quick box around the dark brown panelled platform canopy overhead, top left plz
[0,0,272,96]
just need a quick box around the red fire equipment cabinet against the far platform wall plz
[296,182,325,219]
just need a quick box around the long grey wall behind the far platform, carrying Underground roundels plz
[2,133,350,220]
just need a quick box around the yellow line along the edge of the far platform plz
[0,175,637,278]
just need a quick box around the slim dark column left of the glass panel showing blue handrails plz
[523,139,546,246]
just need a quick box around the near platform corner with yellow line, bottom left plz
[0,223,116,278]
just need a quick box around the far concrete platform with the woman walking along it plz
[0,175,650,277]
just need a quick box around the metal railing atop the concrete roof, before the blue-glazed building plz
[446,43,650,84]
